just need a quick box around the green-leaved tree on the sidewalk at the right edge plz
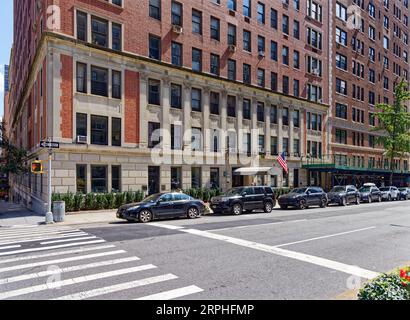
[375,80,410,185]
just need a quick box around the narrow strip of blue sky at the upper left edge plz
[0,0,13,117]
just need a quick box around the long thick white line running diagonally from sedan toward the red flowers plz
[149,224,380,279]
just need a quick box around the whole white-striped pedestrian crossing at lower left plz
[0,226,203,300]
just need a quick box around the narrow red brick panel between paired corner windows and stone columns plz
[124,70,140,144]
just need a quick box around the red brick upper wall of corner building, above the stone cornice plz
[49,0,329,103]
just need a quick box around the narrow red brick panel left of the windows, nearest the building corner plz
[60,54,73,139]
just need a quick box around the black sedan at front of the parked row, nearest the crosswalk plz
[117,193,205,223]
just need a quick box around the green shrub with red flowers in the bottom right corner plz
[358,274,410,300]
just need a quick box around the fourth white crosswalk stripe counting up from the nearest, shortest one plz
[0,257,140,285]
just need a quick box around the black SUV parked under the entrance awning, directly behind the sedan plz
[211,187,276,215]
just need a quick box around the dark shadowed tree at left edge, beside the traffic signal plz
[0,122,27,175]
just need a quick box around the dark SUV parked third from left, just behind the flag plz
[278,187,328,210]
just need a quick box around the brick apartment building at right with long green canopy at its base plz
[305,0,410,189]
